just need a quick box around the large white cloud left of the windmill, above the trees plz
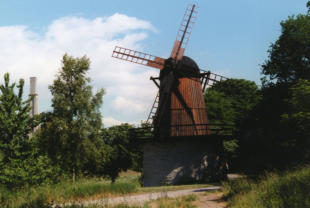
[0,13,158,123]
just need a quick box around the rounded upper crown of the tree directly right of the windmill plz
[205,79,261,125]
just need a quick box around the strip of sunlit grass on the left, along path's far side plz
[0,172,212,208]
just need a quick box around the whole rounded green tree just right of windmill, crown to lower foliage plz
[205,79,261,168]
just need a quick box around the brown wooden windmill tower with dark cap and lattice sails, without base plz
[112,4,227,138]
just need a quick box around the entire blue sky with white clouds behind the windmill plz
[0,0,307,125]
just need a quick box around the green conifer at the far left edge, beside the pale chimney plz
[0,73,35,187]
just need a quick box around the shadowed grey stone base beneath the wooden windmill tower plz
[143,137,227,186]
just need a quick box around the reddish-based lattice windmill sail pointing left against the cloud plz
[112,46,165,69]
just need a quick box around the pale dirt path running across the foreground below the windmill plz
[54,186,225,208]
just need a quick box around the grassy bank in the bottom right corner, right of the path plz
[223,166,310,208]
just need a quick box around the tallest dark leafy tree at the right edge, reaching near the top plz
[248,2,310,169]
